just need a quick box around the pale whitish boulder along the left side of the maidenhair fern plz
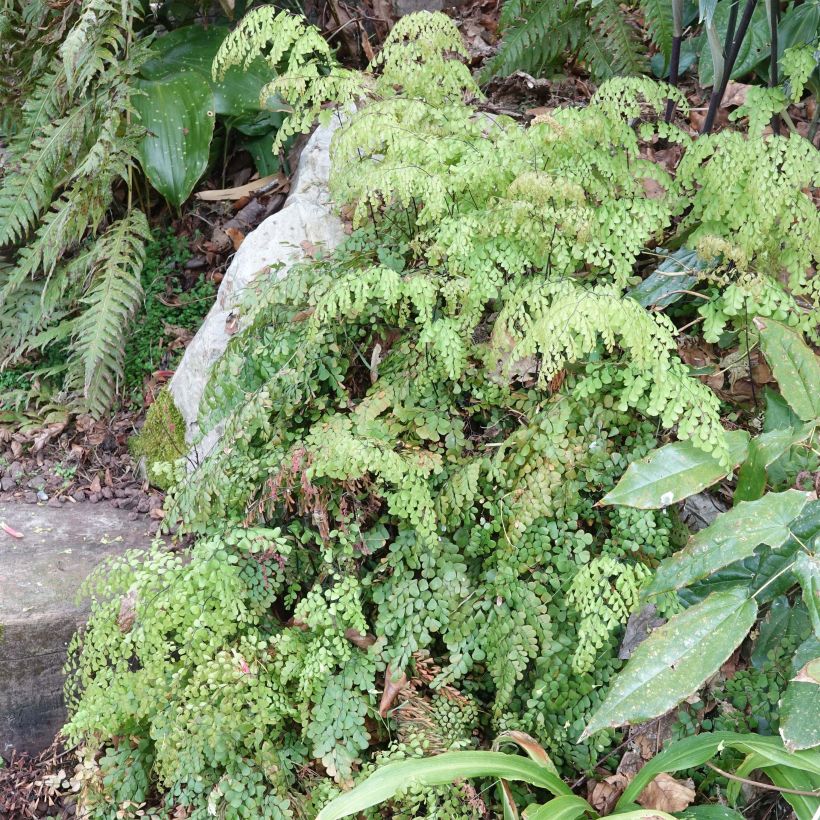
[169,120,344,464]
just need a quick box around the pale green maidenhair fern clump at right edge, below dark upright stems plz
[678,131,820,341]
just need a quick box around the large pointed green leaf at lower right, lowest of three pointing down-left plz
[581,592,757,740]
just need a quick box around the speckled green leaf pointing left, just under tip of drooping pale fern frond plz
[601,430,749,510]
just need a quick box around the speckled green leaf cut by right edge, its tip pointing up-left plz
[755,318,820,421]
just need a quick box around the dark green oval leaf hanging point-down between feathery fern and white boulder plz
[134,72,214,207]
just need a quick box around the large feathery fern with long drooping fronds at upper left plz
[0,0,146,415]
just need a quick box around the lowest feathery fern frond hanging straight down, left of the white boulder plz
[68,209,150,416]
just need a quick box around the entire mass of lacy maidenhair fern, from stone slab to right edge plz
[66,7,818,818]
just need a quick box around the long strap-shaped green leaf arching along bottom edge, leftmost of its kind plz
[316,752,572,820]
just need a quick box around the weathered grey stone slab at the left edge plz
[0,503,156,757]
